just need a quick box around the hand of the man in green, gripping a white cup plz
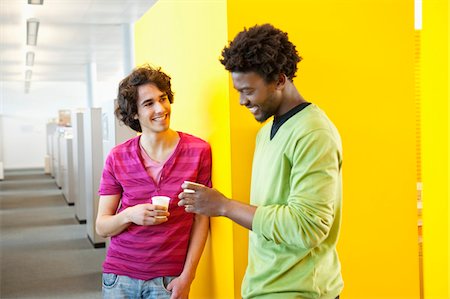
[178,182,229,216]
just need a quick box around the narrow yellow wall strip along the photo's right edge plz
[421,0,450,299]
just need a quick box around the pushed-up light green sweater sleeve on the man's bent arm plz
[253,130,341,249]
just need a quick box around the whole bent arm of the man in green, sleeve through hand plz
[179,130,340,248]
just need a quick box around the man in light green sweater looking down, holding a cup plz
[179,24,343,299]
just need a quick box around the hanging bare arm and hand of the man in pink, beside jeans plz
[167,215,209,299]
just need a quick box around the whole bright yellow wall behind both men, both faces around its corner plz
[136,0,419,299]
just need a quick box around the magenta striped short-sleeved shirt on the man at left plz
[99,132,211,280]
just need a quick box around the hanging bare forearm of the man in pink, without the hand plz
[181,215,209,282]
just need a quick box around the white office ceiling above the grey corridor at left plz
[0,0,157,85]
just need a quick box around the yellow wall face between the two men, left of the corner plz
[135,0,234,299]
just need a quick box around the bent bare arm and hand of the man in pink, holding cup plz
[95,194,169,237]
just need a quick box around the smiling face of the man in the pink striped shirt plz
[135,83,171,134]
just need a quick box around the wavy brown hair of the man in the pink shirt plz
[114,64,173,132]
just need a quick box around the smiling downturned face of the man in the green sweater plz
[231,72,281,122]
